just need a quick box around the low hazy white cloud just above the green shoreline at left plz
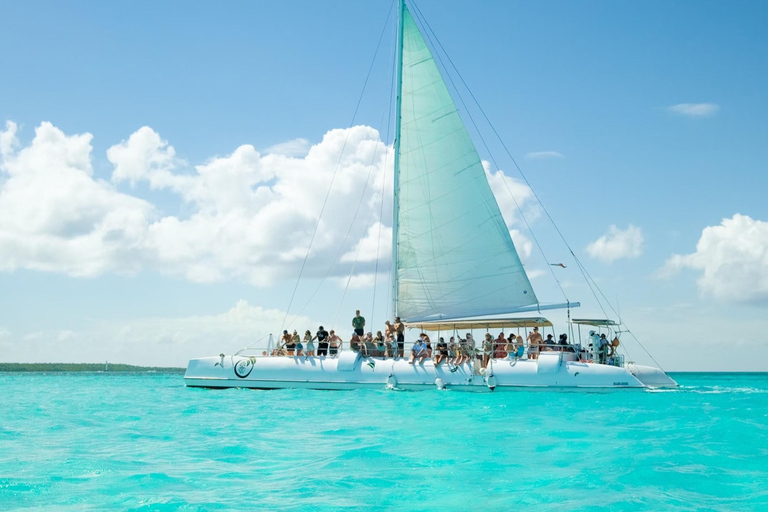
[0,300,317,366]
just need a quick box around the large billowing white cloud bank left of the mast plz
[0,123,393,285]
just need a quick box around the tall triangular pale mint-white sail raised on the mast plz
[393,5,538,322]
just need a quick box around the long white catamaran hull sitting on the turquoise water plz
[184,352,676,391]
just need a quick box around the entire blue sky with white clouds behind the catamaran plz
[0,0,768,371]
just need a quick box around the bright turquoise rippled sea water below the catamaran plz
[0,373,768,511]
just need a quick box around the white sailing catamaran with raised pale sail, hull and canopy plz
[184,0,677,391]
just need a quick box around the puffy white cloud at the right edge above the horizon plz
[659,214,768,302]
